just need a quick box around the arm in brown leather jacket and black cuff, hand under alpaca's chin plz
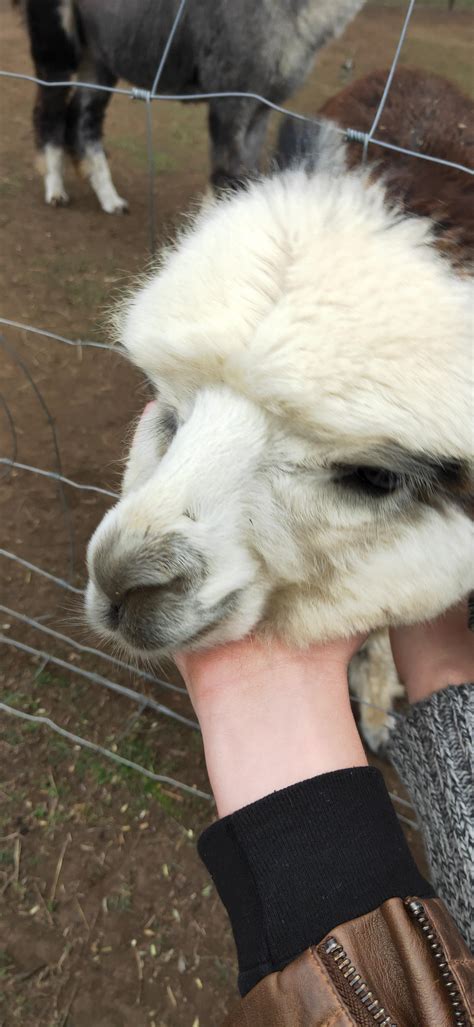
[175,640,471,1027]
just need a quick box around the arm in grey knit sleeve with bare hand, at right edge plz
[388,603,474,949]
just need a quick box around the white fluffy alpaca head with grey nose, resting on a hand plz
[86,170,474,654]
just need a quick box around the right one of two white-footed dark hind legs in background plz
[67,62,128,214]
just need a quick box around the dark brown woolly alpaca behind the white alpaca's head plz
[319,68,474,271]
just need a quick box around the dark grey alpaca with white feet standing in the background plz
[24,0,363,214]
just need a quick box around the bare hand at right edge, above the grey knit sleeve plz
[390,602,474,702]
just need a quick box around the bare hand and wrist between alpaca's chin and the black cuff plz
[175,636,366,816]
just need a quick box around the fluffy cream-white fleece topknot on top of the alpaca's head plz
[122,170,472,456]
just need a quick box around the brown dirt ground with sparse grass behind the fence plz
[0,0,473,1027]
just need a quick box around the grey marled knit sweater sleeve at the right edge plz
[388,684,474,950]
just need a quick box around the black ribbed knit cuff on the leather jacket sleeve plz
[198,767,433,994]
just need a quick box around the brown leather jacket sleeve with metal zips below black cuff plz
[226,898,474,1027]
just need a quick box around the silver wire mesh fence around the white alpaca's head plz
[0,0,474,829]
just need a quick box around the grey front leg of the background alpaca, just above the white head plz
[209,100,268,189]
